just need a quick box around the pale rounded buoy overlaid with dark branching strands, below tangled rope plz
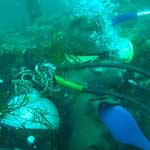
[1,91,60,130]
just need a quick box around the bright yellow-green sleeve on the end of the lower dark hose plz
[55,76,83,92]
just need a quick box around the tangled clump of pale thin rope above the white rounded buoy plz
[13,63,60,95]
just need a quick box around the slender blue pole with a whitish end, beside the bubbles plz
[112,11,150,25]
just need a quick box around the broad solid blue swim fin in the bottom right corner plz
[99,105,150,150]
